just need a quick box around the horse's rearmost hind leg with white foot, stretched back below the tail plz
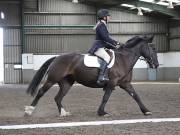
[25,81,53,115]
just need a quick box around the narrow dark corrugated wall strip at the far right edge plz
[170,20,180,51]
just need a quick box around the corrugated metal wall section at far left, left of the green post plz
[0,0,22,83]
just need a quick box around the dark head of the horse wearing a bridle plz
[141,35,159,68]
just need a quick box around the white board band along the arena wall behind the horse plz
[22,52,180,70]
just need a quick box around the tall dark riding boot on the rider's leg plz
[97,61,109,84]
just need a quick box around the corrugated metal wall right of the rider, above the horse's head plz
[109,9,169,52]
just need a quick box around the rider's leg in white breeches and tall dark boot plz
[94,48,110,83]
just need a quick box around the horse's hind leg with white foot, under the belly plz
[54,77,74,116]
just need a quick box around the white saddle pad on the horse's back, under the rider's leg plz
[84,50,115,68]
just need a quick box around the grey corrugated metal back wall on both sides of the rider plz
[24,0,169,53]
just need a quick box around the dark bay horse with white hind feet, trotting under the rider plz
[25,36,159,116]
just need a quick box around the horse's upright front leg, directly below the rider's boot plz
[97,88,112,116]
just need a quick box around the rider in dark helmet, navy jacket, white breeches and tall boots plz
[88,9,120,84]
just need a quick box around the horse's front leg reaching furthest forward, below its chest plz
[119,83,152,115]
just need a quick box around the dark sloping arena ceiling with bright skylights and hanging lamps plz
[68,0,180,20]
